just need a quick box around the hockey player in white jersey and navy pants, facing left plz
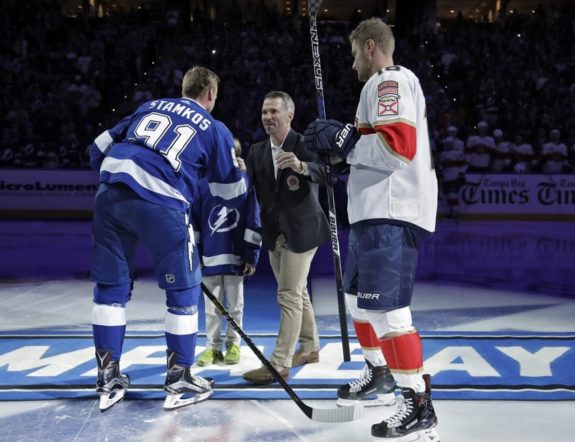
[305,18,439,441]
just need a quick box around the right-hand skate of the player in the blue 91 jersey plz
[164,350,214,410]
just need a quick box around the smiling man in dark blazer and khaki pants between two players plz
[243,91,330,384]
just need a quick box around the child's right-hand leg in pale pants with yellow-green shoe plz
[223,275,244,364]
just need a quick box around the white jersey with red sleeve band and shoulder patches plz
[347,66,437,232]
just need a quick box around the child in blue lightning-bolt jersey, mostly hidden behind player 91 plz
[192,139,262,367]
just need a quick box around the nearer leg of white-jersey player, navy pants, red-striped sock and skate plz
[358,224,437,438]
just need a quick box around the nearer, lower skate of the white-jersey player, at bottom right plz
[371,374,439,442]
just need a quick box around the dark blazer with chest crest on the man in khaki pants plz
[246,130,330,253]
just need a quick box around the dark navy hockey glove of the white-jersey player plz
[304,120,361,159]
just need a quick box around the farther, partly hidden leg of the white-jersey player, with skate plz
[337,227,395,406]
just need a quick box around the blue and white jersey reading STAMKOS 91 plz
[90,98,247,212]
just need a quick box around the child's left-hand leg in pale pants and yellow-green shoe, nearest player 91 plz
[196,275,225,367]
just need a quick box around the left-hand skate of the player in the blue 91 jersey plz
[96,350,130,411]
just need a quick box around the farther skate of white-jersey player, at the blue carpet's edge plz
[337,360,395,407]
